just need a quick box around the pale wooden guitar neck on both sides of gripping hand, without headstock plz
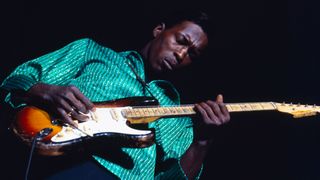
[122,102,276,118]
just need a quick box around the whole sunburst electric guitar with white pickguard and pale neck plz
[12,97,320,156]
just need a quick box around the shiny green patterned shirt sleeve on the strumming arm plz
[0,39,91,108]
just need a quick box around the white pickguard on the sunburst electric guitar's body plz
[51,107,151,142]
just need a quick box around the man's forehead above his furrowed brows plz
[171,21,208,46]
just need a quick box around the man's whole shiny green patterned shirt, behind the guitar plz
[1,39,202,179]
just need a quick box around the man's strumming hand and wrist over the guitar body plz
[25,83,94,126]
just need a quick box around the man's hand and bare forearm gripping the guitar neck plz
[180,95,230,179]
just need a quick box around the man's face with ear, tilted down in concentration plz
[148,21,208,72]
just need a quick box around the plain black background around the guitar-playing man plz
[0,0,320,180]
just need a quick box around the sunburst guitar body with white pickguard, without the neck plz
[12,97,158,156]
